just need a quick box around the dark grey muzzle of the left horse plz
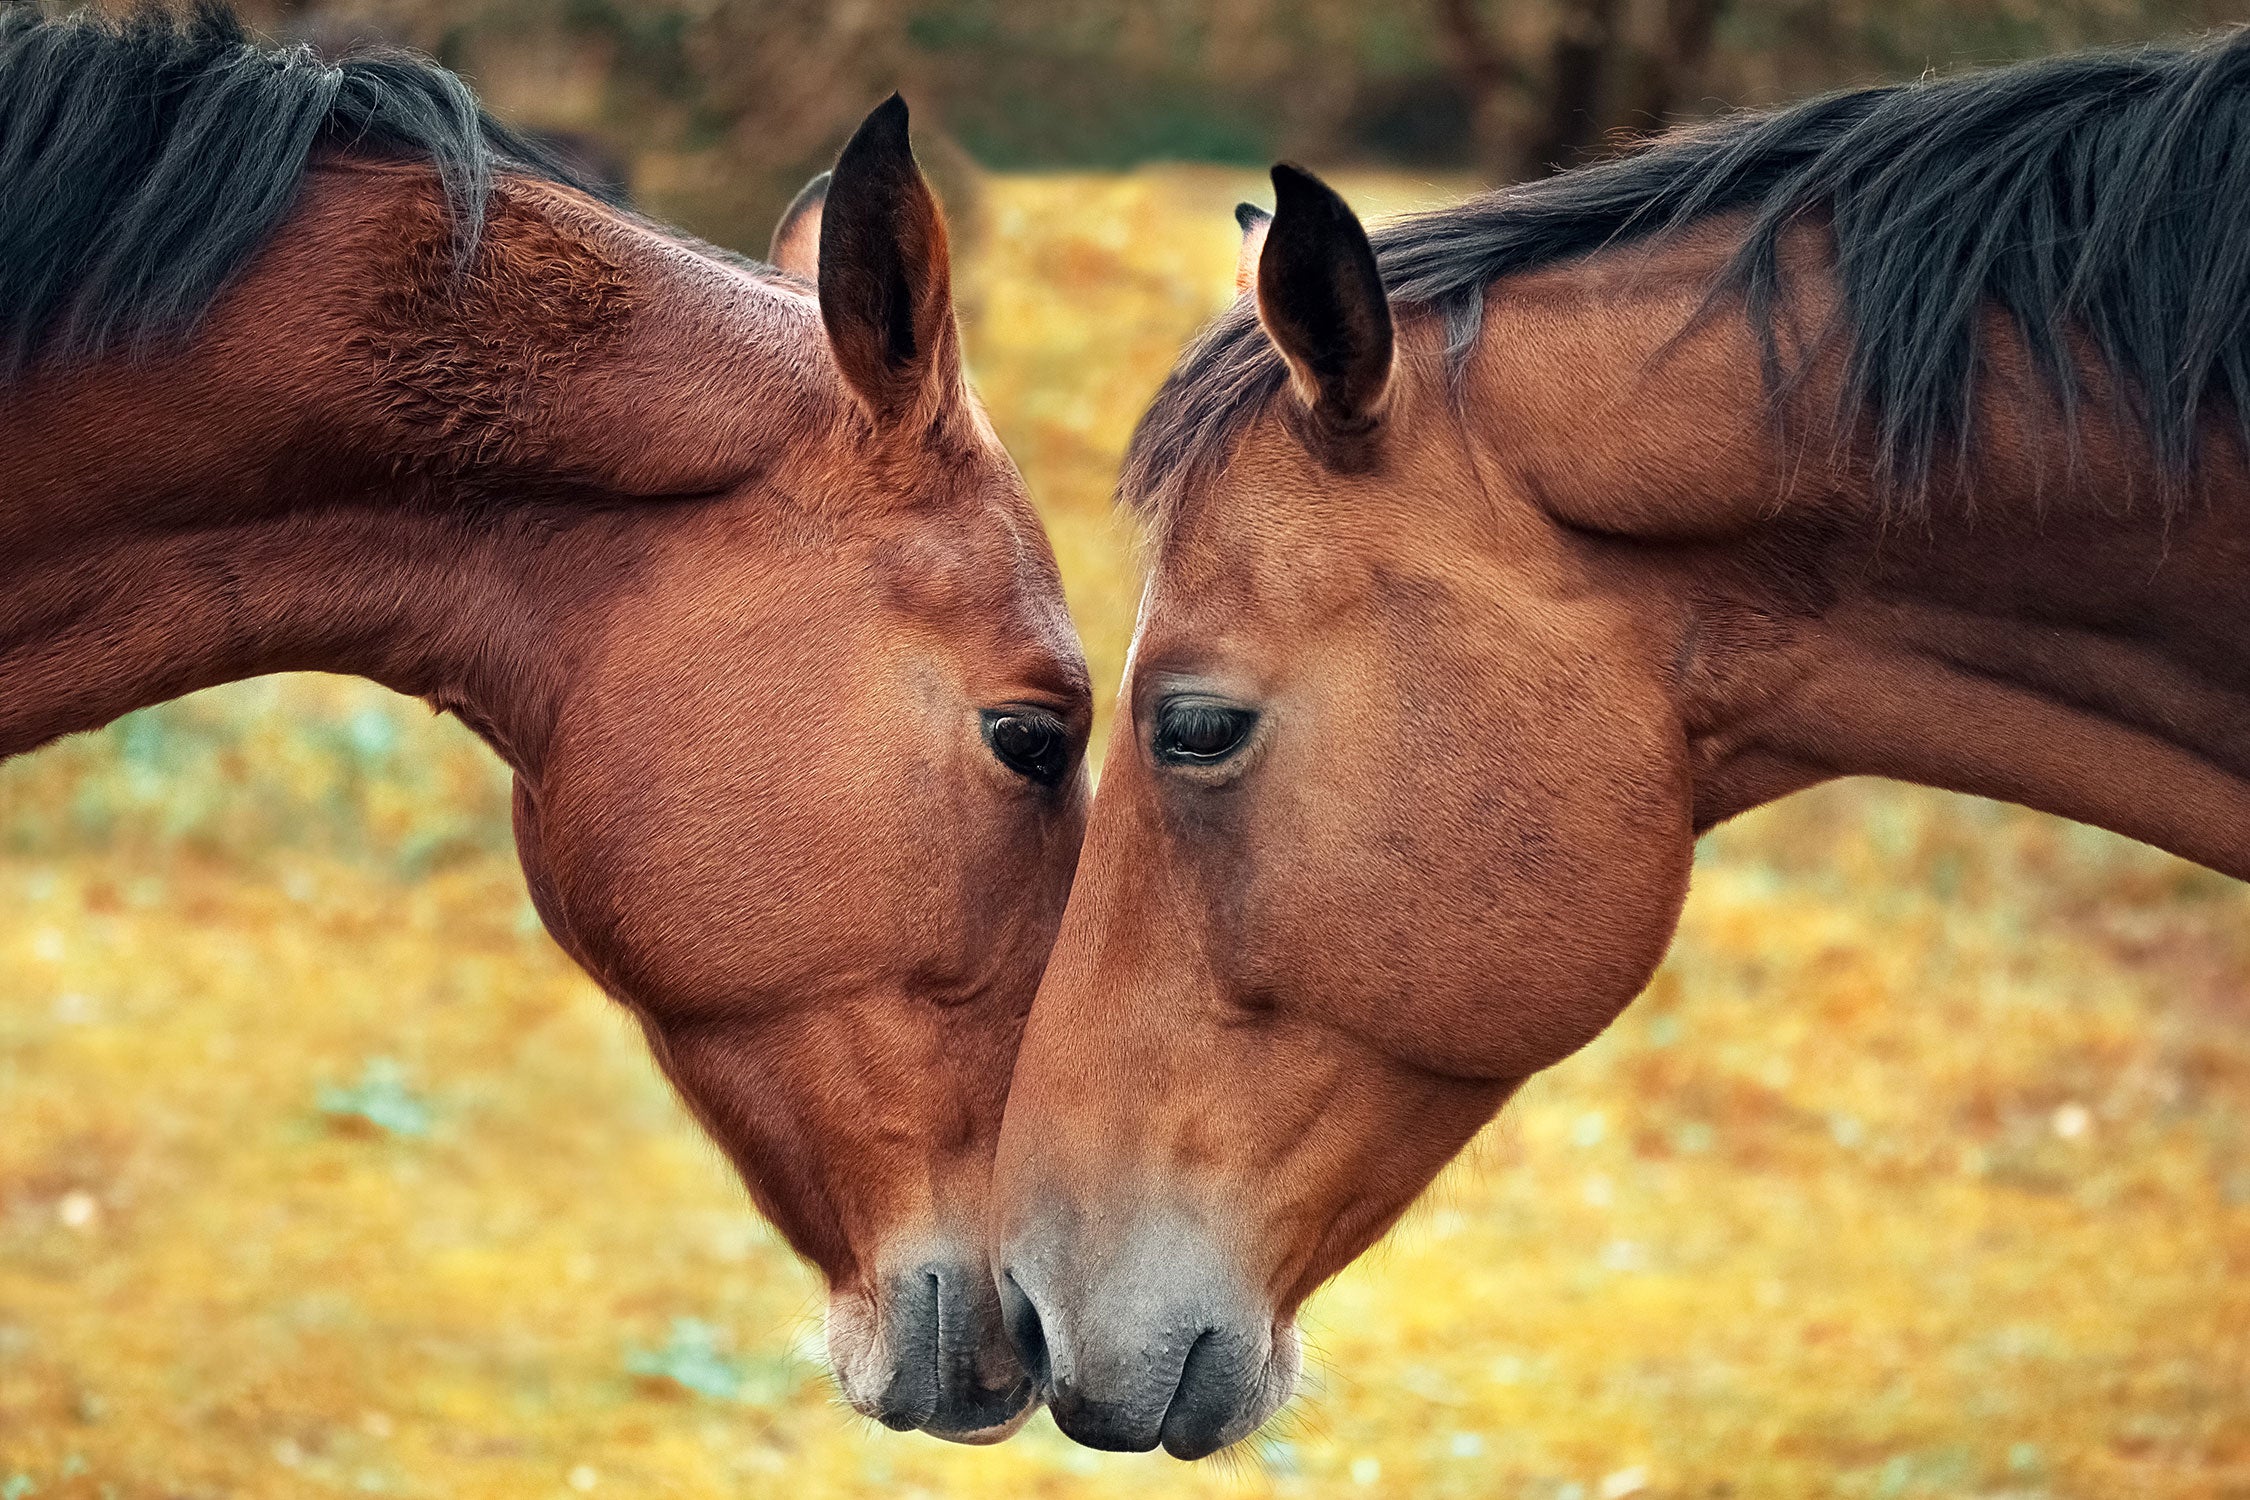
[828,1253,1037,1444]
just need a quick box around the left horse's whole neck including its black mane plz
[0,9,848,769]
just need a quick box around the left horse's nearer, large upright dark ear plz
[819,94,961,421]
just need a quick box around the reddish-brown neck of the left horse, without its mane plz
[0,169,812,769]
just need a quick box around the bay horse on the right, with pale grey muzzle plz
[995,34,2250,1457]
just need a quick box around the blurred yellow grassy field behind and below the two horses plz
[0,173,2250,1500]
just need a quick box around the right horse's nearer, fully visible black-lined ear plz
[1258,164,1391,432]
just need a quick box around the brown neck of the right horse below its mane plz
[1474,247,2250,877]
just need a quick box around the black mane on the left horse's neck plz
[0,0,601,382]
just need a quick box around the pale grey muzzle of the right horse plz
[999,1219,1301,1460]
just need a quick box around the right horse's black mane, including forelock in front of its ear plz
[1121,31,2250,513]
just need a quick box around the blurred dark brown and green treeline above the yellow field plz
[223,0,2237,245]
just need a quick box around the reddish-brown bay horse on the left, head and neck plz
[0,7,1089,1439]
